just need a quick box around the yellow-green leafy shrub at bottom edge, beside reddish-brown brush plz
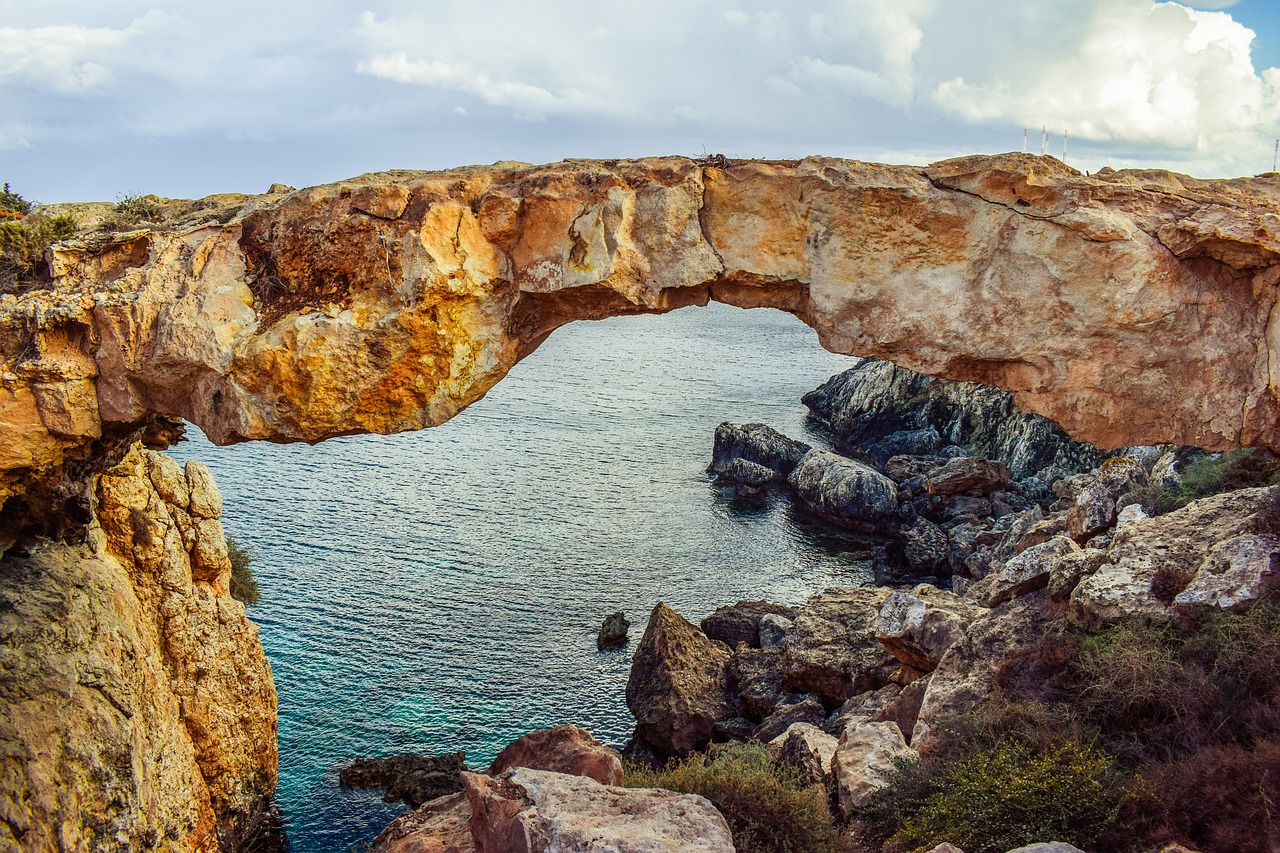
[890,740,1128,853]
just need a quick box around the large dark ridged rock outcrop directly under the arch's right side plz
[804,359,1107,479]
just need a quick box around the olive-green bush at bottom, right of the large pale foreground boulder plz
[626,743,854,853]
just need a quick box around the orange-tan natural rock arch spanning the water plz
[0,155,1280,525]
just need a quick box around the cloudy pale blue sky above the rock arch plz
[0,0,1280,202]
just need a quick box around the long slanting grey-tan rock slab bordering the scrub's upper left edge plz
[911,593,1051,749]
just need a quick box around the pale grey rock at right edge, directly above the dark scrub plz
[1174,534,1280,610]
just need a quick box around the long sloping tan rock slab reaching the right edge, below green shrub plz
[1068,487,1280,626]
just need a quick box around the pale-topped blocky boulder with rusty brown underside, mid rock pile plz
[876,584,982,672]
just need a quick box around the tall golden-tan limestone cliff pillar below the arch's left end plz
[0,446,278,853]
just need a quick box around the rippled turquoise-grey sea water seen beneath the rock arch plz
[170,305,869,853]
